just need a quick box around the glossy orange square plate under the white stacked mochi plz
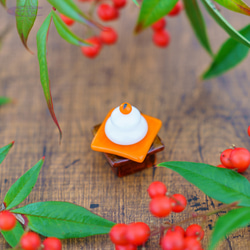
[91,109,162,163]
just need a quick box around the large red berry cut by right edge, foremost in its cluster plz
[229,148,250,173]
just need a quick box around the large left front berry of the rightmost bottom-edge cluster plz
[161,231,184,250]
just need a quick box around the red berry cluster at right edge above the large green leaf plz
[217,147,250,173]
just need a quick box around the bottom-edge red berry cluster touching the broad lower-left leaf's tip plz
[109,222,150,250]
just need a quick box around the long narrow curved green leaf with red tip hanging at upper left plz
[36,13,62,139]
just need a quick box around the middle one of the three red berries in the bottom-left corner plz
[20,232,41,250]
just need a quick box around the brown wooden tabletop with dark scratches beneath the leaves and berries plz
[0,0,250,250]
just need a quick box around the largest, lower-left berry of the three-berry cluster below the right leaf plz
[149,196,172,217]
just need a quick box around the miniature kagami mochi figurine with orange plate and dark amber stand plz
[91,103,164,177]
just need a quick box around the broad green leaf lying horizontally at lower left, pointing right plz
[11,201,115,239]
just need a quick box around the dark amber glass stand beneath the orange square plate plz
[92,124,164,177]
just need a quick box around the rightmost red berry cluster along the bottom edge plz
[161,224,204,250]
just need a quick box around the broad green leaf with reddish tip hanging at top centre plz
[135,0,178,32]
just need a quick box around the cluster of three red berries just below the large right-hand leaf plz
[147,181,187,218]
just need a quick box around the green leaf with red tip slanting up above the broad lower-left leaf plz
[4,158,44,209]
